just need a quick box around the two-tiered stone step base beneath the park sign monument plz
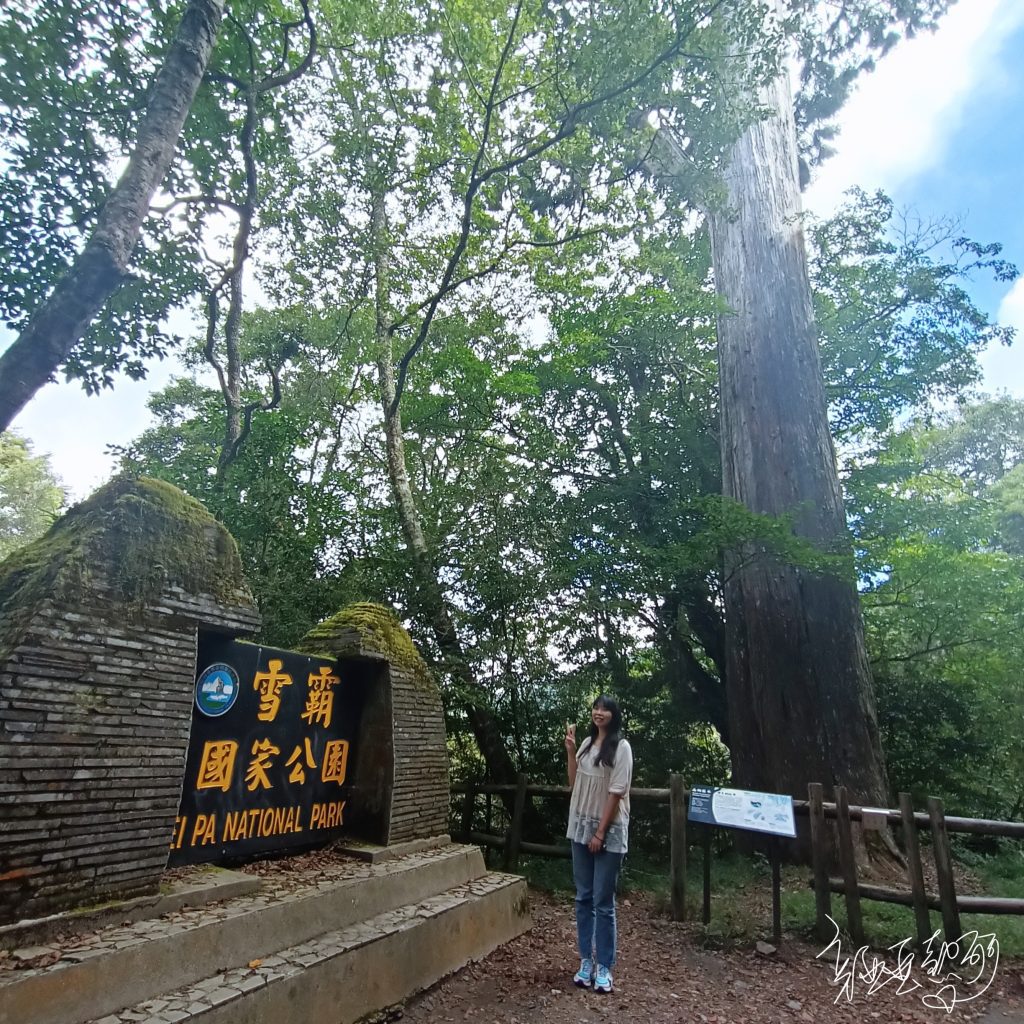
[0,842,530,1024]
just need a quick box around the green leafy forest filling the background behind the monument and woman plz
[0,0,1024,839]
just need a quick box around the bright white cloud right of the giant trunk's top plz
[805,0,1024,215]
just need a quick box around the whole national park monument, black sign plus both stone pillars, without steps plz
[0,476,450,925]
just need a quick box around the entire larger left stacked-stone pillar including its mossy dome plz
[0,480,258,923]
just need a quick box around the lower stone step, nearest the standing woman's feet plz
[82,874,529,1024]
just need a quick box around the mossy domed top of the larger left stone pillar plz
[0,476,253,656]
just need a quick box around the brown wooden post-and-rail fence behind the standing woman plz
[452,775,1024,944]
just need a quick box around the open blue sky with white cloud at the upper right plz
[804,0,1024,397]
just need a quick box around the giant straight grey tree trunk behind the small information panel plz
[710,68,886,804]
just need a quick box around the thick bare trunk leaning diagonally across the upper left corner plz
[0,0,224,430]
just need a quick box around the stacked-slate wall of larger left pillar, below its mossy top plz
[0,588,258,923]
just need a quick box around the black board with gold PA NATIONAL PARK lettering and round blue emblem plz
[169,637,361,866]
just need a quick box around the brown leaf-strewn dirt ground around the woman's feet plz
[388,891,1024,1024]
